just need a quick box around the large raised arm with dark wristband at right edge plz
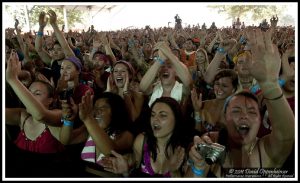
[247,29,295,167]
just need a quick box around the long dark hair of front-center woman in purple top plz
[146,97,188,161]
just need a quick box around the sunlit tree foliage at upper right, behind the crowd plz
[208,5,286,22]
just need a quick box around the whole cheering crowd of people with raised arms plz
[5,10,295,178]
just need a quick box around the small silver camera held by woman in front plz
[196,143,225,165]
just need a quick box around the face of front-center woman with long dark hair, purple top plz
[151,102,175,138]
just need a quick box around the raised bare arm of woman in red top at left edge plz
[6,52,61,126]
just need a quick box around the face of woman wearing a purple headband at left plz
[60,60,79,81]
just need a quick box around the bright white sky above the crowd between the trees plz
[3,2,298,30]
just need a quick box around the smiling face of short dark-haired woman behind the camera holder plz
[214,77,234,99]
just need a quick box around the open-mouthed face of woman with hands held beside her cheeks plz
[113,63,129,88]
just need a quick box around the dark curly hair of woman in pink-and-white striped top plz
[94,92,130,135]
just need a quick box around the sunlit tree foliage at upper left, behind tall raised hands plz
[5,5,84,29]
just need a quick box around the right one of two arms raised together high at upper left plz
[48,10,75,57]
